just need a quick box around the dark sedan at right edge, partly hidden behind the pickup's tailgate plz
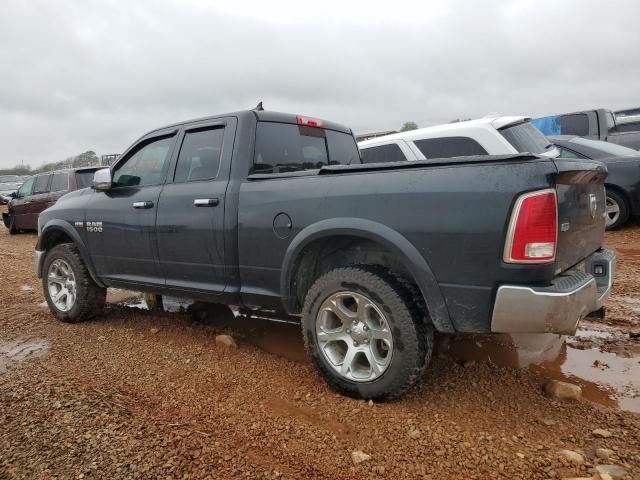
[549,135,640,230]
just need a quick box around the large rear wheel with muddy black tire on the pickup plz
[302,266,433,400]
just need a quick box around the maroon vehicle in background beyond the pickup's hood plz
[2,167,98,234]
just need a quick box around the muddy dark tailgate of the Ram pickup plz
[554,158,607,273]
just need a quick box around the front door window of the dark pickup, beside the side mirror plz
[113,136,174,187]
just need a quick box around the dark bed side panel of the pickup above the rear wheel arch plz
[238,159,556,331]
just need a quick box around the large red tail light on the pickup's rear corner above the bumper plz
[504,189,558,263]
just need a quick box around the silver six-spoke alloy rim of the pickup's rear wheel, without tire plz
[316,291,393,382]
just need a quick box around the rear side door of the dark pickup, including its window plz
[156,118,236,293]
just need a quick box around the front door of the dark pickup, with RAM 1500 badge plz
[84,133,175,285]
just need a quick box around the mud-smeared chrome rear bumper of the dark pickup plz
[491,249,616,334]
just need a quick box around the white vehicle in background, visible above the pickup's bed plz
[358,116,560,163]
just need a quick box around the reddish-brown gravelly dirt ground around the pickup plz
[0,223,640,479]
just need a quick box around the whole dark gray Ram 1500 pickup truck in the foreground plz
[35,111,615,399]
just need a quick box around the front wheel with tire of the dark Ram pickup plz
[42,243,107,323]
